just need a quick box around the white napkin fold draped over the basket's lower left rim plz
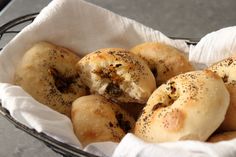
[0,83,81,148]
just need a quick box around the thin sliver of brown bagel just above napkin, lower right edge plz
[207,131,236,143]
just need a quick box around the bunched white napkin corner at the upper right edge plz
[189,26,236,66]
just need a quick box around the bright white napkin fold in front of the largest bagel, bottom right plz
[113,134,236,157]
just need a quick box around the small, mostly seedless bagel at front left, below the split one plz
[71,95,135,146]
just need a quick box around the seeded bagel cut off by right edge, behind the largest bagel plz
[208,57,236,131]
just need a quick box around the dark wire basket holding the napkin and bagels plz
[0,13,198,157]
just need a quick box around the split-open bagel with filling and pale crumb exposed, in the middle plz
[77,48,156,104]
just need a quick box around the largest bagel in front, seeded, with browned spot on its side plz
[134,70,229,142]
